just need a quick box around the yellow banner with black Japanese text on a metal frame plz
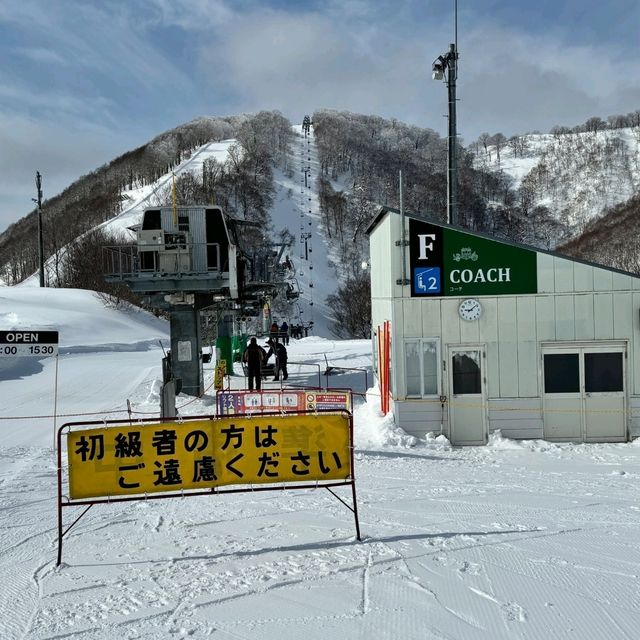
[67,414,352,499]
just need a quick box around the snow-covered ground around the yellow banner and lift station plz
[0,287,640,640]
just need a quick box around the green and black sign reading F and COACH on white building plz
[409,219,538,297]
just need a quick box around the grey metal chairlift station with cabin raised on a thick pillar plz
[104,205,298,410]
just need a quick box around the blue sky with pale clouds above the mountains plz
[0,0,640,232]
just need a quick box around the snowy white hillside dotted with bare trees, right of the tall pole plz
[473,126,640,235]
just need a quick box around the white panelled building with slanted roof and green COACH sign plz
[368,207,640,445]
